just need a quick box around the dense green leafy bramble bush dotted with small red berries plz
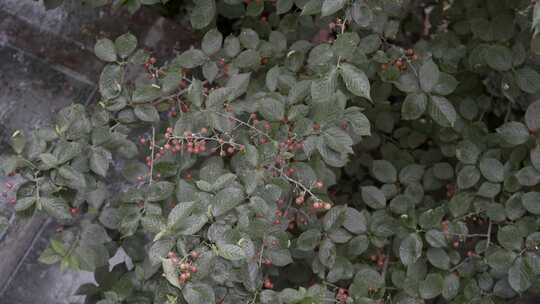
[5,0,540,304]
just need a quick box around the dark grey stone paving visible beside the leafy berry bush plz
[0,0,194,304]
